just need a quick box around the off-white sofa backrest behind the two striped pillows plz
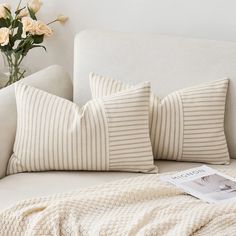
[74,30,236,158]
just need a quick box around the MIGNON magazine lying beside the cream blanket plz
[161,165,236,203]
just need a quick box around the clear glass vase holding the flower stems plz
[0,51,26,88]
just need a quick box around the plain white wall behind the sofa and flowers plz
[3,0,236,74]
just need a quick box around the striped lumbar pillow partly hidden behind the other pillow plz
[90,73,230,164]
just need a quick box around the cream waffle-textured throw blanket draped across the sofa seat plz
[0,171,236,236]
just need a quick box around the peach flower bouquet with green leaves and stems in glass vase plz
[0,0,67,87]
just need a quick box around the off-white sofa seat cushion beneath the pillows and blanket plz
[0,160,236,211]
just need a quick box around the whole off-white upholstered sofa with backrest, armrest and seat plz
[0,30,236,211]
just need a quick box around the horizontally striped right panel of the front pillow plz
[104,87,153,171]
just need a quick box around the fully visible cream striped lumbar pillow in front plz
[7,83,157,174]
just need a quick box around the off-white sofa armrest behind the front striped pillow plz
[0,65,73,178]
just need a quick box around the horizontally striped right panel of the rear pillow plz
[180,79,229,164]
